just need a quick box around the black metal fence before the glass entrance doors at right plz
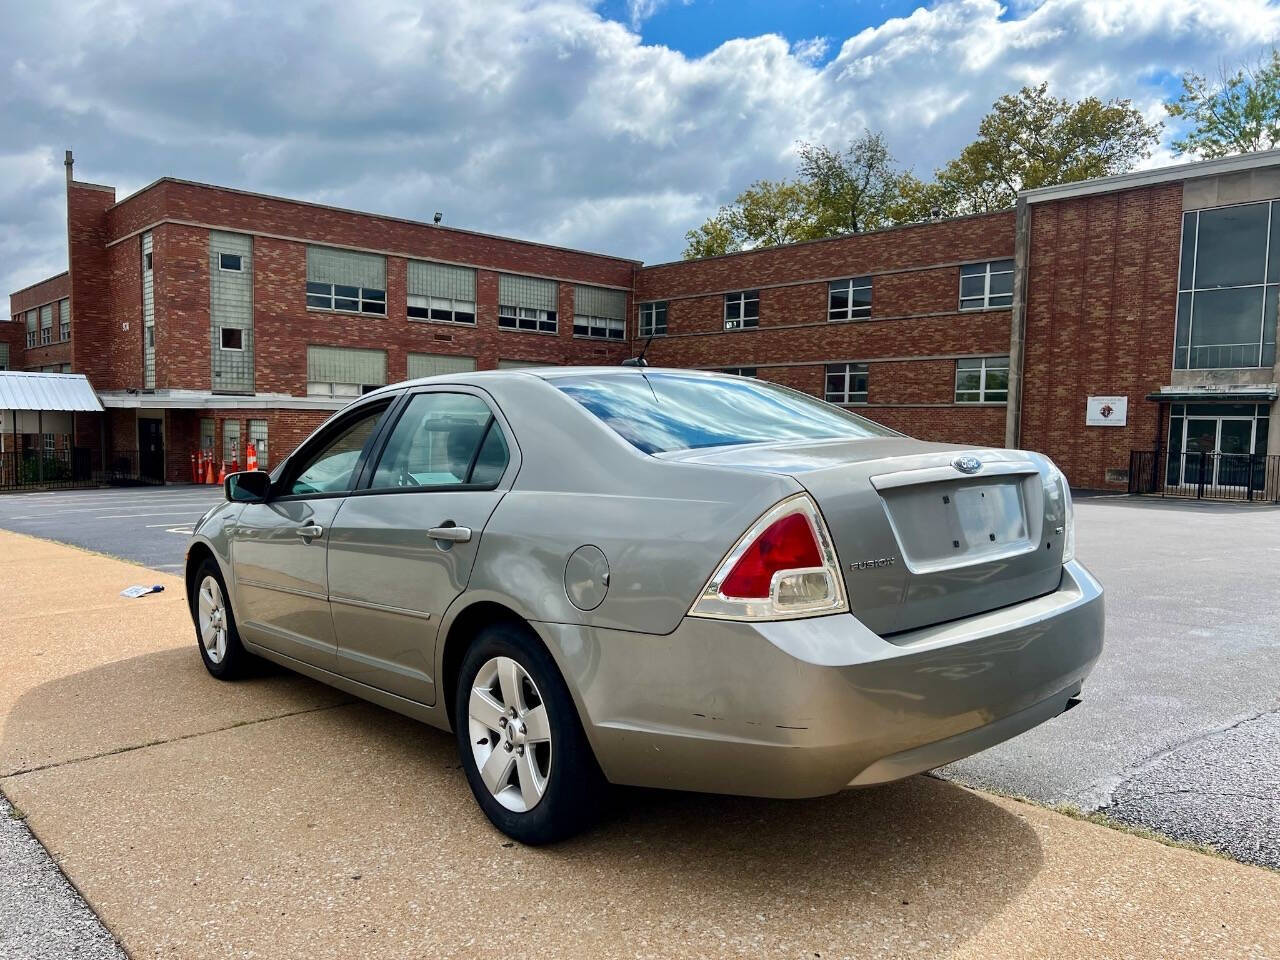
[1129,451,1280,503]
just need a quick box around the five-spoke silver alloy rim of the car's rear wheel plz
[467,657,552,813]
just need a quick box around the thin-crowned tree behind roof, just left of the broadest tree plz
[799,131,909,237]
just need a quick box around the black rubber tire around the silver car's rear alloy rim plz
[453,623,605,846]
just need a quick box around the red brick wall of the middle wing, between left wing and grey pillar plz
[636,212,1014,445]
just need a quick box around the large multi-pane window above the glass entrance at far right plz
[1174,201,1280,370]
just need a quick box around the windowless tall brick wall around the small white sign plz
[1020,183,1183,489]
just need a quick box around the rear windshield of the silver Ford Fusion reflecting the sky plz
[550,371,899,453]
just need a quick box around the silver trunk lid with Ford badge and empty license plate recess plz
[664,438,1064,635]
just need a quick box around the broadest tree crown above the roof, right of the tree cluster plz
[934,83,1160,214]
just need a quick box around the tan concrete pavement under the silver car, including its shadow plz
[0,532,1280,959]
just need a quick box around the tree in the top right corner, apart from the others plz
[1165,47,1280,160]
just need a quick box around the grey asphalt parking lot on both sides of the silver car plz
[0,486,1280,868]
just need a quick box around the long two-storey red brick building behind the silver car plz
[10,151,1280,489]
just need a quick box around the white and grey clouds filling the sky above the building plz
[0,0,1280,299]
